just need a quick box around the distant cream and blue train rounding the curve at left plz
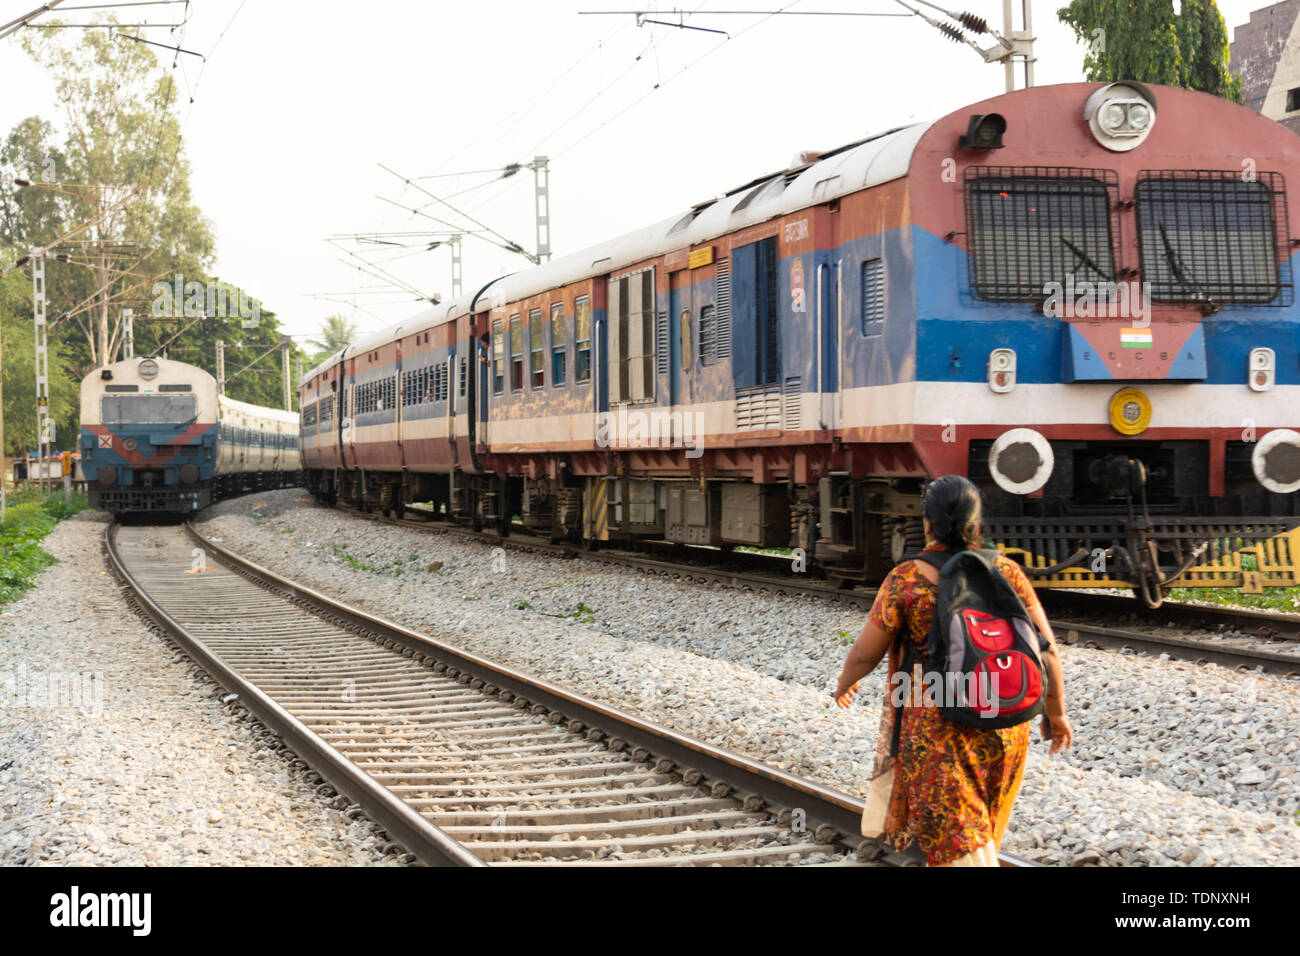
[81,358,300,514]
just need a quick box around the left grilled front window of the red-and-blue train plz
[966,166,1118,302]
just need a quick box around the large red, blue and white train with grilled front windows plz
[300,83,1300,605]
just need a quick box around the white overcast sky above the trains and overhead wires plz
[0,0,1268,337]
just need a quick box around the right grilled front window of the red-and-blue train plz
[1134,170,1292,307]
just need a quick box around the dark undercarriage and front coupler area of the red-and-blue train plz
[304,442,1300,607]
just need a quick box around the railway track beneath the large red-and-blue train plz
[319,509,1300,678]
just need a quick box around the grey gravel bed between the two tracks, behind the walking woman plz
[200,489,1300,865]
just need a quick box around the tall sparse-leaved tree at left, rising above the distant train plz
[0,21,213,371]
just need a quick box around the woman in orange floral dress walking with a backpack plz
[835,475,1074,866]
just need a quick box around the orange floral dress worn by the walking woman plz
[863,545,1039,866]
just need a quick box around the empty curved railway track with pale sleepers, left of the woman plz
[105,525,1032,866]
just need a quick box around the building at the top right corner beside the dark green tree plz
[1229,0,1300,133]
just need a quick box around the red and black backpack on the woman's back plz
[893,551,1048,753]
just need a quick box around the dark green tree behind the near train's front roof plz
[1057,0,1242,103]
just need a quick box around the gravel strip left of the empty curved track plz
[0,511,398,866]
